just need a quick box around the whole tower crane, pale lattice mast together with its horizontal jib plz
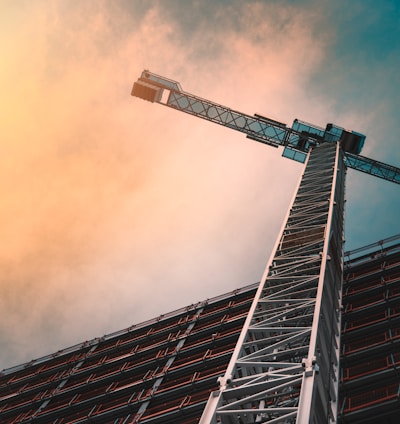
[132,70,400,424]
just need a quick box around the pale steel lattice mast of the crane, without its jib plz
[200,143,346,424]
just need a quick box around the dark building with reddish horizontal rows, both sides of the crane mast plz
[0,236,400,424]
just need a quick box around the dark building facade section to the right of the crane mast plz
[339,237,400,424]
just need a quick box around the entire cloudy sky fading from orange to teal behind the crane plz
[0,0,400,370]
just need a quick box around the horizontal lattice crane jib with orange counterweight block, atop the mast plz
[132,70,400,184]
